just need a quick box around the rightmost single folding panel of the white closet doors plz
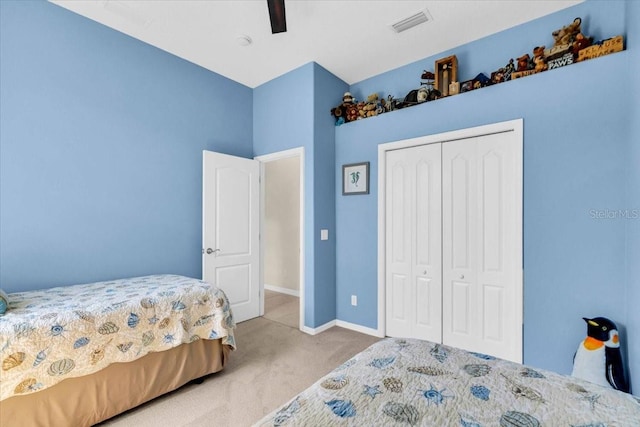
[476,132,522,362]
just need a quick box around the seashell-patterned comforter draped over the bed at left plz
[0,275,235,400]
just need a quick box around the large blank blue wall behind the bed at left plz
[0,0,252,292]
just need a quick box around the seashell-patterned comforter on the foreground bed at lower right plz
[255,338,640,427]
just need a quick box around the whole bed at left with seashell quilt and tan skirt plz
[0,275,235,426]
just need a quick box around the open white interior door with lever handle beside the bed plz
[202,151,260,322]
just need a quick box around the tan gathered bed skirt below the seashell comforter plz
[0,339,231,427]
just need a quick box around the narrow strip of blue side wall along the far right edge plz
[622,1,640,395]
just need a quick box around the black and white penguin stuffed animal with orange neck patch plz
[571,317,629,393]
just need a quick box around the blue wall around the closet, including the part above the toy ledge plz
[335,2,638,382]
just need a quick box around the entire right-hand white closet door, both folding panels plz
[442,132,522,362]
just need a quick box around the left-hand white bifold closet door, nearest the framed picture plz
[386,144,442,342]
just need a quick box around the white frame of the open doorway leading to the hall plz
[254,147,305,330]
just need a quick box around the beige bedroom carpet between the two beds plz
[101,310,378,427]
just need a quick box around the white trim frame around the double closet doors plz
[377,119,524,343]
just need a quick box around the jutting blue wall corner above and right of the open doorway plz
[253,63,347,328]
